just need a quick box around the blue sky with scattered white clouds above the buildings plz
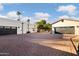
[0,3,79,22]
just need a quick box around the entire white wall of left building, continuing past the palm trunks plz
[0,18,34,34]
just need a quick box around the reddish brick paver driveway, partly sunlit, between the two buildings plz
[0,33,76,56]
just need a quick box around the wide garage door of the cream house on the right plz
[54,26,75,34]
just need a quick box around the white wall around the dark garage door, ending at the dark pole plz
[0,18,22,34]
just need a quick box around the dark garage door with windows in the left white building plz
[0,26,17,35]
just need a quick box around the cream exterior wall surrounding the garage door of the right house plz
[52,20,79,35]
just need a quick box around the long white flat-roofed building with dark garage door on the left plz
[0,18,35,35]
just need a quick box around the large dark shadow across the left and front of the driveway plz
[0,34,76,56]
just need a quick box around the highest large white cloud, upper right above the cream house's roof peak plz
[57,5,77,14]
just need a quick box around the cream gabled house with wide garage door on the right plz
[52,19,79,35]
